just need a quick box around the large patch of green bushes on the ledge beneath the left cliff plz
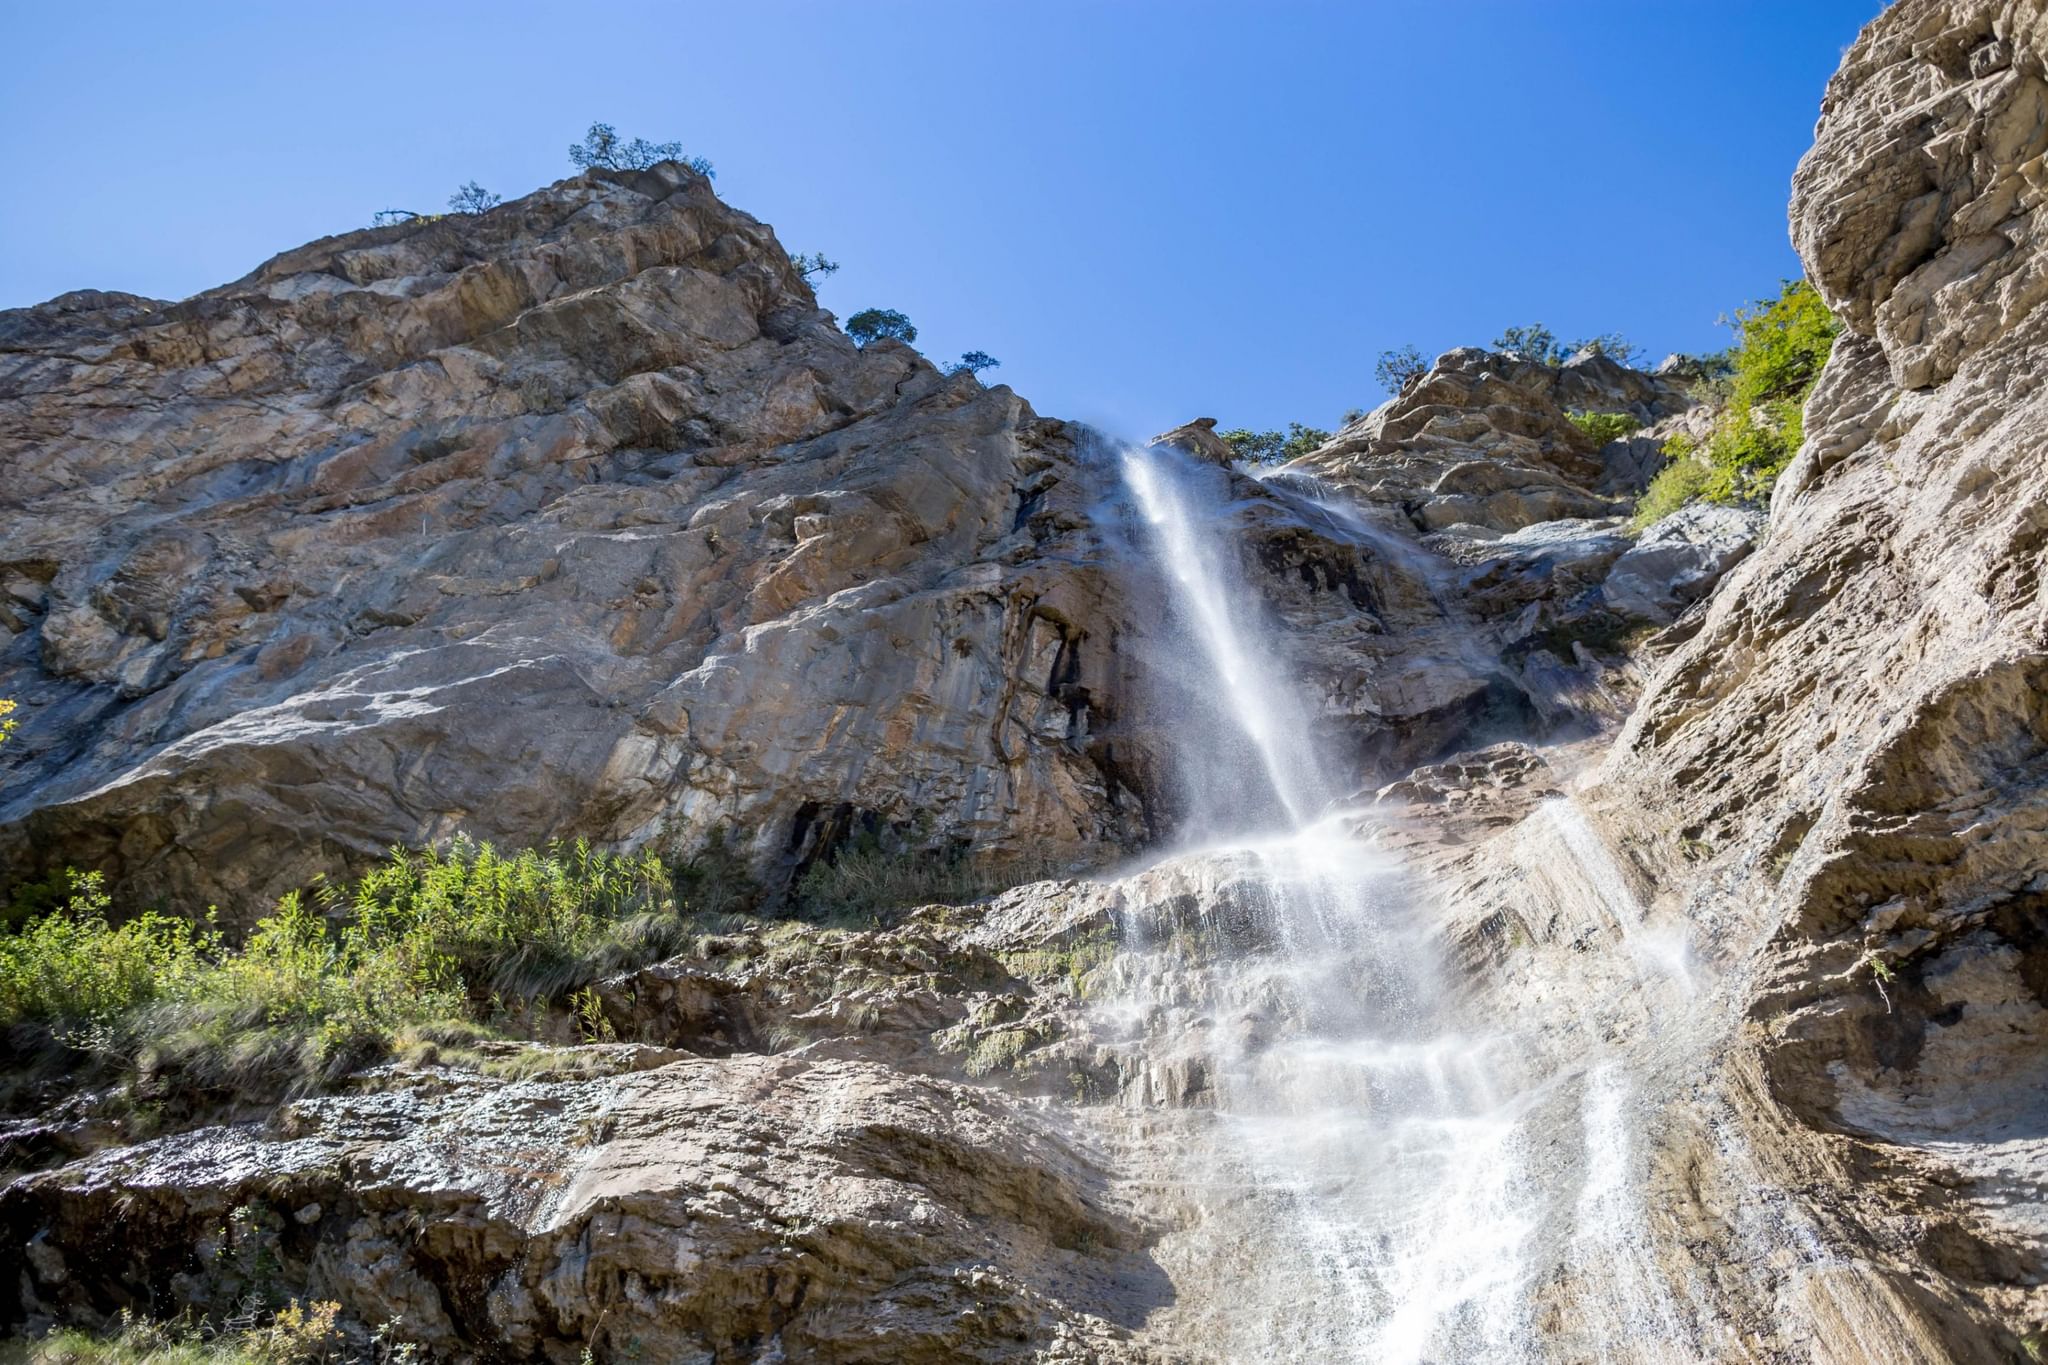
[0,839,686,1089]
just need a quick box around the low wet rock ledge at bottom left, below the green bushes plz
[0,1056,1159,1363]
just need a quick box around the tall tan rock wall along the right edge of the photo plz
[1604,0,2048,1361]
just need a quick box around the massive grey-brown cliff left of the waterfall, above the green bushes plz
[0,166,1143,907]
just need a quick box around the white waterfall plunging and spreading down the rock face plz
[1100,448,1692,1365]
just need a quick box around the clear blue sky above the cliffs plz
[0,0,1878,436]
